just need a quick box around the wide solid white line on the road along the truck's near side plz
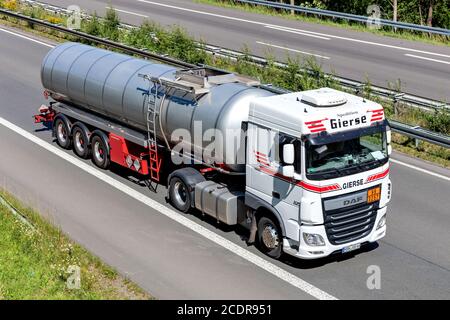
[0,117,337,300]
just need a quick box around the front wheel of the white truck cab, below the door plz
[258,215,283,259]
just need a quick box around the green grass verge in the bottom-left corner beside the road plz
[0,189,151,300]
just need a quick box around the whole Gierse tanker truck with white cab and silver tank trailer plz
[35,43,392,259]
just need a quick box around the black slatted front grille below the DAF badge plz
[324,202,379,245]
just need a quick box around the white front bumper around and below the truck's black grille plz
[283,207,386,259]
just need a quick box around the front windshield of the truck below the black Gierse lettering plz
[306,131,388,180]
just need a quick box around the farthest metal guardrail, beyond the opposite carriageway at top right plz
[232,0,450,37]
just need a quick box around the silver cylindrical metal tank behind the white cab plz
[41,42,274,171]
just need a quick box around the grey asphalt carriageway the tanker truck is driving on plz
[0,26,450,299]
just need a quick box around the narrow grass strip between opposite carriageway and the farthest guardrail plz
[194,0,450,46]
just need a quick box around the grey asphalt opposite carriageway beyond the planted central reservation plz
[42,0,450,101]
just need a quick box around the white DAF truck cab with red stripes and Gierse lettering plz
[245,88,392,259]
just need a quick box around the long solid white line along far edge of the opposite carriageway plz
[136,0,450,58]
